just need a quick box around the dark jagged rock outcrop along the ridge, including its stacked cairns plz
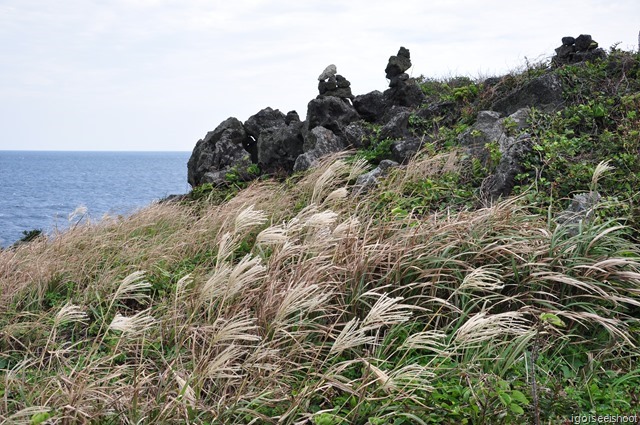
[188,35,605,200]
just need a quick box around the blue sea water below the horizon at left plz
[0,151,190,247]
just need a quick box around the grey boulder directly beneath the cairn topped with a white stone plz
[307,96,360,137]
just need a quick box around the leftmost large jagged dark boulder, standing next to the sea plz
[187,117,251,187]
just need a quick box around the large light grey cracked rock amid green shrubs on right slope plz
[459,108,532,200]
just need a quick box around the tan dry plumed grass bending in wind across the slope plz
[0,154,640,424]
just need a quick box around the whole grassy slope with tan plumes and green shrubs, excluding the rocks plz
[0,48,640,425]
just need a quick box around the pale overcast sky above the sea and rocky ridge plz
[0,0,640,151]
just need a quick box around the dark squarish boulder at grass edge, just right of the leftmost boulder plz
[258,121,304,173]
